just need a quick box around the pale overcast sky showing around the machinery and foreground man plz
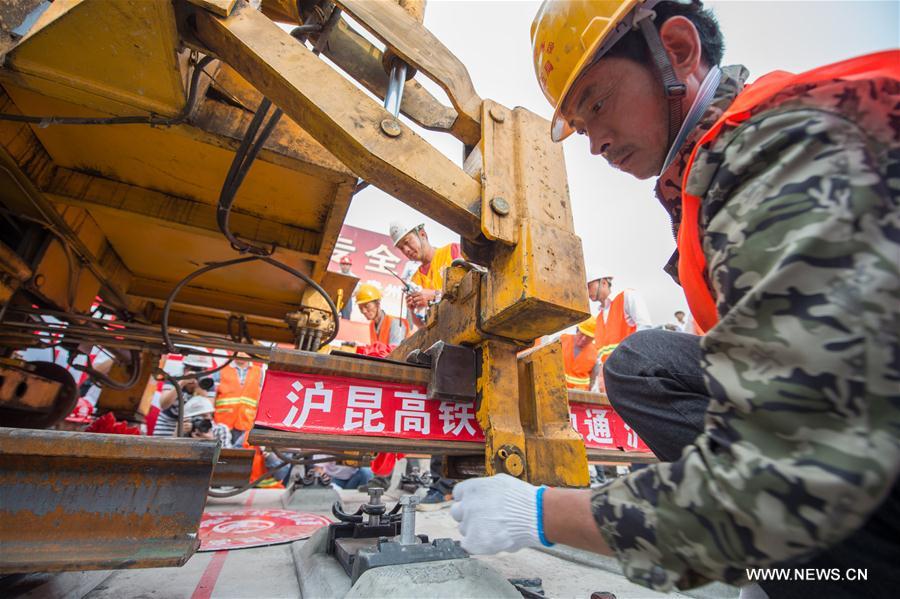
[346,0,900,324]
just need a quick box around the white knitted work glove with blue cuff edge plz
[450,474,552,554]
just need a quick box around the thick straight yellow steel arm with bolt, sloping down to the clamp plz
[196,5,481,239]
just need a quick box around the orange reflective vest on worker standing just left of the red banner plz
[215,352,263,444]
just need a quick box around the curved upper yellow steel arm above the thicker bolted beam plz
[337,0,481,143]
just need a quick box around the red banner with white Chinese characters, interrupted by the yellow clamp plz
[256,370,649,452]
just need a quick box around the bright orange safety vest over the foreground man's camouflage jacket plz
[678,50,900,331]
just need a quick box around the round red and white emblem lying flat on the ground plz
[198,510,331,551]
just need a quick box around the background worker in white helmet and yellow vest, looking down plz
[389,222,462,327]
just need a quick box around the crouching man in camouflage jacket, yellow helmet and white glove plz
[451,1,900,599]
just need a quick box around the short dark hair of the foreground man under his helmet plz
[603,0,725,67]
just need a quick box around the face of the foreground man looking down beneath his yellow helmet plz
[561,57,668,179]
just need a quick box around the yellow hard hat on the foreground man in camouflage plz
[531,0,658,141]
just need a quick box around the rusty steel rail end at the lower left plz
[0,428,219,574]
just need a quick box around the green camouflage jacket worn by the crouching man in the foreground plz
[592,62,900,590]
